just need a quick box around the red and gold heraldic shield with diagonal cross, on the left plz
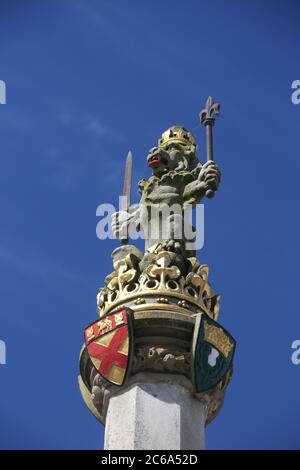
[85,308,132,386]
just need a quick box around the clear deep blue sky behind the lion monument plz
[0,0,300,449]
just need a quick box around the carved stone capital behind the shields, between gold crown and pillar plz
[79,305,231,424]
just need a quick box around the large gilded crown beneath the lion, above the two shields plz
[97,251,220,320]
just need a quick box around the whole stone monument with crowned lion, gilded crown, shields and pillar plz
[79,97,235,450]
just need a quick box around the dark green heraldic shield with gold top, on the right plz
[192,313,236,393]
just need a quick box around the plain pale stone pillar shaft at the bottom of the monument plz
[104,374,206,450]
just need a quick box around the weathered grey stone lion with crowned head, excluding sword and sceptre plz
[112,126,221,256]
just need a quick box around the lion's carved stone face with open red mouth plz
[147,142,196,175]
